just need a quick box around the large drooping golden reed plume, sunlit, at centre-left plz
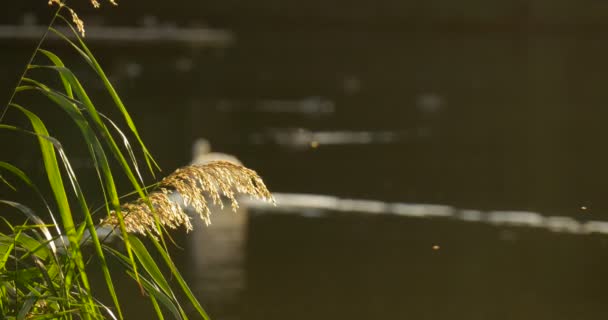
[102,161,274,235]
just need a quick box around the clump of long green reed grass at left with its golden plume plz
[0,0,272,319]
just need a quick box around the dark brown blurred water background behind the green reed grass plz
[0,0,608,320]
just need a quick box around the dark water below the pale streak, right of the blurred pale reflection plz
[243,215,608,319]
